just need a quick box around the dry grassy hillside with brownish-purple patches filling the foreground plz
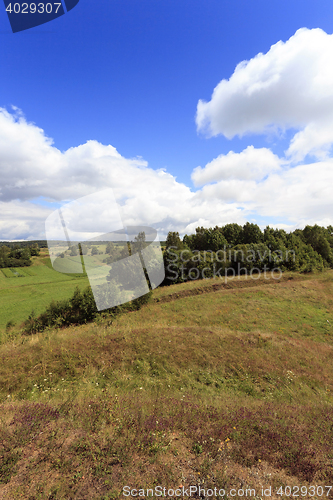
[0,268,333,499]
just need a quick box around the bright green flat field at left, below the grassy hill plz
[0,249,89,330]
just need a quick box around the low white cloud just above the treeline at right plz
[197,155,333,227]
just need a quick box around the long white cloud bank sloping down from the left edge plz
[0,109,246,240]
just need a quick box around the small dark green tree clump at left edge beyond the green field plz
[0,241,39,269]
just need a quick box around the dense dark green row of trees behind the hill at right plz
[163,222,333,285]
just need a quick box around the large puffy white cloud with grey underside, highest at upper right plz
[196,28,333,161]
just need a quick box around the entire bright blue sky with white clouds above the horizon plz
[0,0,333,240]
